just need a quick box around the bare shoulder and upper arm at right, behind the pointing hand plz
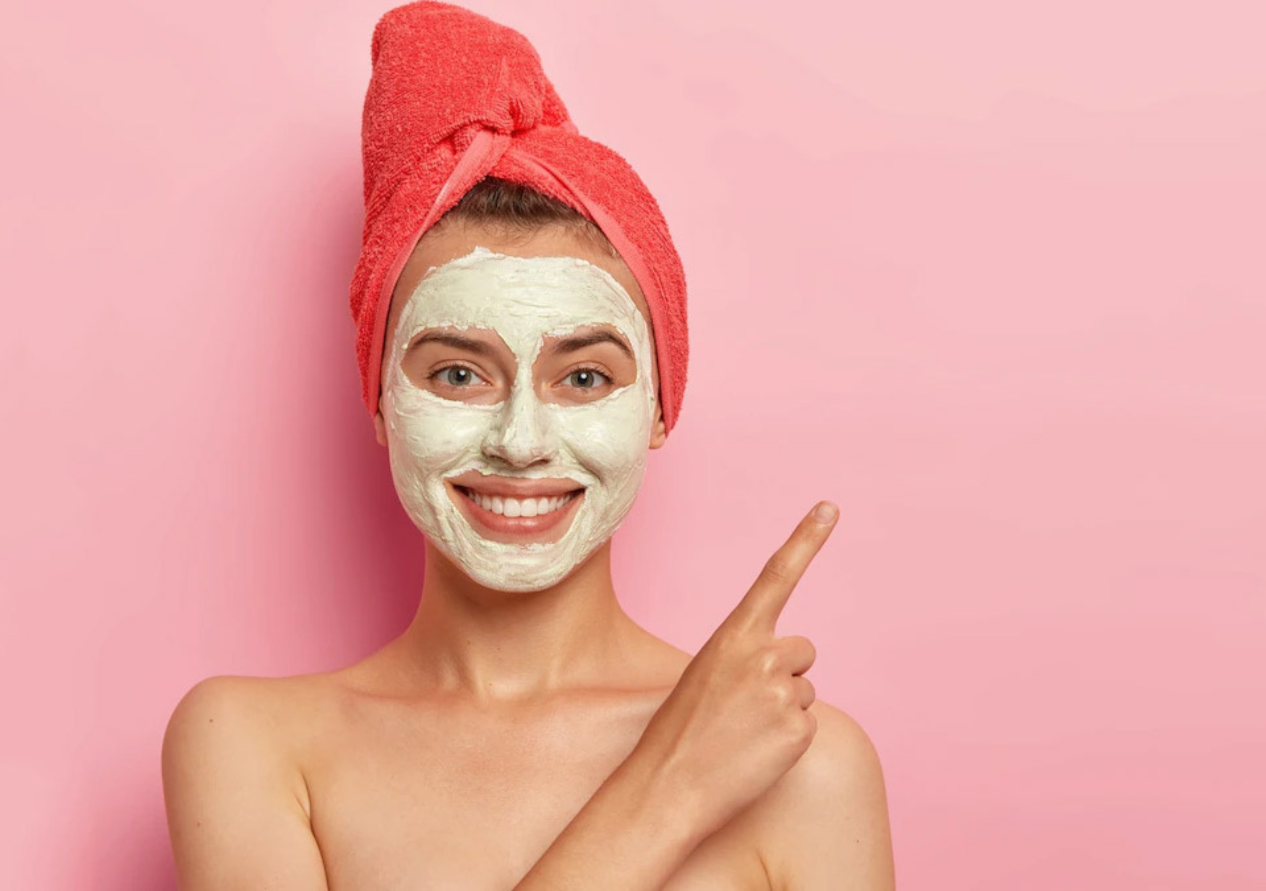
[762,700,895,891]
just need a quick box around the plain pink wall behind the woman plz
[0,0,1266,891]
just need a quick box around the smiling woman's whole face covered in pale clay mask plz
[379,224,665,591]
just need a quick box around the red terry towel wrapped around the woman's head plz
[352,3,687,430]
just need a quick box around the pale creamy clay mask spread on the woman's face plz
[381,247,656,591]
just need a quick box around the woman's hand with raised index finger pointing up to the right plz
[630,501,839,833]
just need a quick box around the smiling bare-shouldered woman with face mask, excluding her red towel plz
[163,4,894,891]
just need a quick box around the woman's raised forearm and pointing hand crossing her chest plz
[514,505,840,891]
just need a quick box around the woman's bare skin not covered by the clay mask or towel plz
[163,218,894,891]
